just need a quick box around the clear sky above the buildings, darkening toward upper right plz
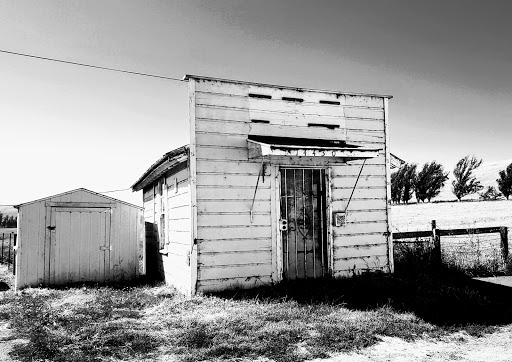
[0,0,512,205]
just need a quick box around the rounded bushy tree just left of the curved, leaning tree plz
[415,161,448,202]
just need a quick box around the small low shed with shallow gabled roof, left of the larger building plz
[15,189,145,289]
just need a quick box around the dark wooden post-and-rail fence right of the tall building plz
[393,220,509,272]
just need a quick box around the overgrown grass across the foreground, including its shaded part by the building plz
[0,251,512,361]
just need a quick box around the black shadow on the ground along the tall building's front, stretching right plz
[216,267,512,327]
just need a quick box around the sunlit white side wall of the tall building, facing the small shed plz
[144,168,192,294]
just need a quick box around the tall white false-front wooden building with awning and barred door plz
[132,75,393,293]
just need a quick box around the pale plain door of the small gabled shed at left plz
[48,207,111,284]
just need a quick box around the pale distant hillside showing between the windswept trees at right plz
[433,159,512,201]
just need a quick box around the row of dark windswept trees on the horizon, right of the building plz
[391,155,512,204]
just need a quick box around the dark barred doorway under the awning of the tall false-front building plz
[280,168,327,279]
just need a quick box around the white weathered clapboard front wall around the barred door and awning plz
[189,79,390,291]
